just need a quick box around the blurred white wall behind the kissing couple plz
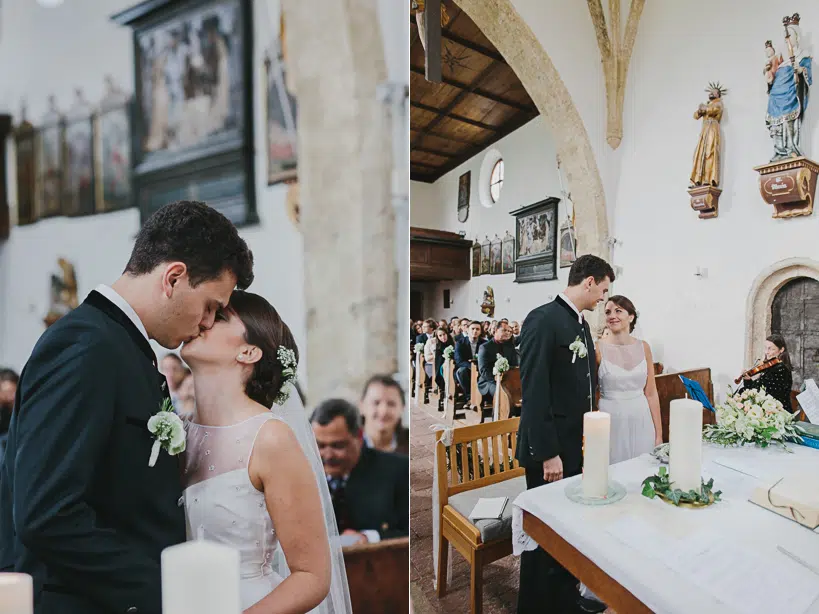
[0,0,408,377]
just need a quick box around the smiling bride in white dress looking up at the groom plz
[597,296,663,464]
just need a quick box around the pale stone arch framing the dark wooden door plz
[745,258,819,366]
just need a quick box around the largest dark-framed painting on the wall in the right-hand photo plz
[510,197,560,283]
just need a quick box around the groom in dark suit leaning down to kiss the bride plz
[0,201,253,614]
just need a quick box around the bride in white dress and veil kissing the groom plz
[182,290,352,614]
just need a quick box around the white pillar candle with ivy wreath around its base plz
[668,399,702,492]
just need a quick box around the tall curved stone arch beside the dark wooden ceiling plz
[455,0,609,258]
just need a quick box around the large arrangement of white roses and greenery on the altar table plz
[703,388,804,448]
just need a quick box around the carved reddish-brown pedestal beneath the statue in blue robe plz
[754,157,819,218]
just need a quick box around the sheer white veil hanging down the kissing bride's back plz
[271,394,353,614]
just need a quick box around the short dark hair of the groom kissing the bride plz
[125,200,253,290]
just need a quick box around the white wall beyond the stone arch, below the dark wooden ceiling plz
[410,118,569,320]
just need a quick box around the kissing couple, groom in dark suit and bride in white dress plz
[0,201,351,614]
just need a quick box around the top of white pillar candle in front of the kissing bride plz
[162,541,242,614]
